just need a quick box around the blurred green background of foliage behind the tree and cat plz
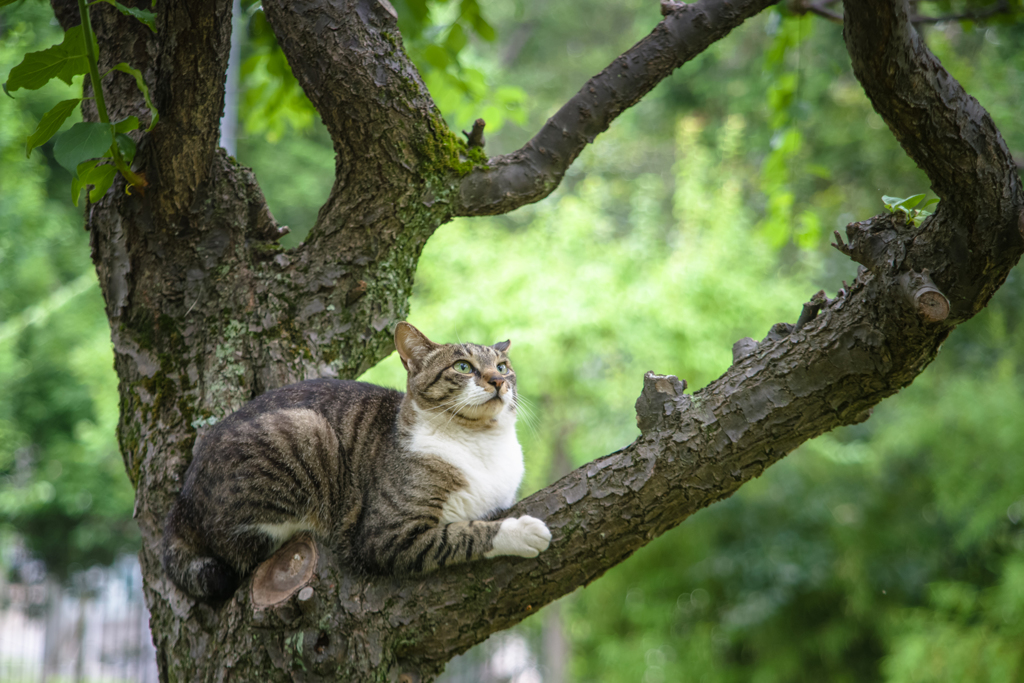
[6,0,1024,683]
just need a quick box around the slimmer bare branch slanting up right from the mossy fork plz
[455,0,777,216]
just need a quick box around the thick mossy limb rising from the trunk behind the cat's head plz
[251,0,465,382]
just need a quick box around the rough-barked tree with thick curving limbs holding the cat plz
[28,0,1024,680]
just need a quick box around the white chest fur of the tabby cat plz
[410,419,523,524]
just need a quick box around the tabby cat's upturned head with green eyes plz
[394,323,516,422]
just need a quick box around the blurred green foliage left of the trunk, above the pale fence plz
[0,3,138,579]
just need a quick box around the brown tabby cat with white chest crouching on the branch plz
[163,323,551,602]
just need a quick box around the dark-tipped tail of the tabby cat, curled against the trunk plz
[164,502,240,602]
